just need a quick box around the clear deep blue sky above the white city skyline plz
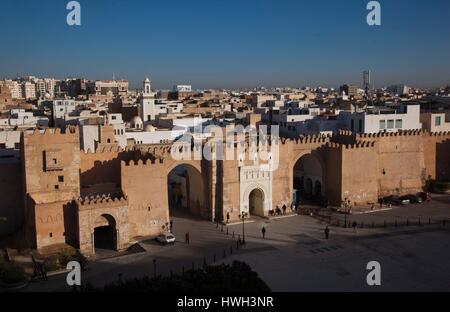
[0,0,450,88]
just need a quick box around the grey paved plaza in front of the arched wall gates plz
[25,197,450,291]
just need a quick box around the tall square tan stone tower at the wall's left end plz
[22,128,80,248]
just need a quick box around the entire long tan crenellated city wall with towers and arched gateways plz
[7,128,450,252]
